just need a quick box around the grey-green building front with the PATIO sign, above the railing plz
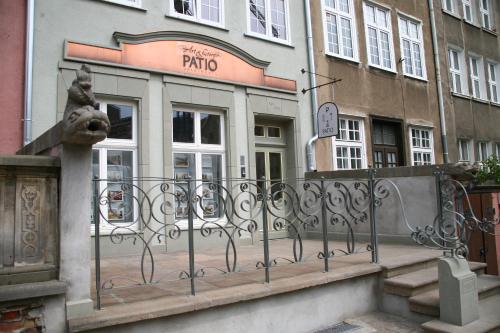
[29,0,313,231]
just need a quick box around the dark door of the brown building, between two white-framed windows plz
[373,119,403,168]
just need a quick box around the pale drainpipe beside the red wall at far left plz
[23,0,35,145]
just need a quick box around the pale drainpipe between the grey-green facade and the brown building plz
[304,0,318,171]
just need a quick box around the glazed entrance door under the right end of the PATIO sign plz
[255,147,288,238]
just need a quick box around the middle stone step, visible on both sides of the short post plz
[408,274,500,317]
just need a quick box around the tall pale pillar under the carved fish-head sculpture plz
[59,144,93,319]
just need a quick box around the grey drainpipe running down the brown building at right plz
[428,0,449,164]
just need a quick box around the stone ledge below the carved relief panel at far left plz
[0,281,66,302]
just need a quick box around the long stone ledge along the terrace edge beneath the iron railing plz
[69,264,381,332]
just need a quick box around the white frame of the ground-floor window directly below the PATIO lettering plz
[172,106,226,230]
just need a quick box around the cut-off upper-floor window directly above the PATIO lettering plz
[174,0,224,26]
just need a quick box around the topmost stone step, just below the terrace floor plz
[384,262,486,297]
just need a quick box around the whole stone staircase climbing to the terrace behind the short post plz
[382,255,500,333]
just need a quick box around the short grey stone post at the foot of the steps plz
[438,257,479,326]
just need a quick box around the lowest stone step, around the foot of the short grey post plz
[421,295,500,333]
